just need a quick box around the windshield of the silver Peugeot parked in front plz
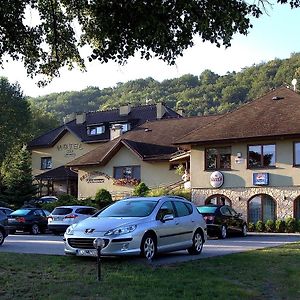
[95,200,157,217]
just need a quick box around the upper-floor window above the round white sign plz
[205,147,231,170]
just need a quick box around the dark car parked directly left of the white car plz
[8,208,48,234]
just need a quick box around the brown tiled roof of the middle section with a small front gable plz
[68,116,219,166]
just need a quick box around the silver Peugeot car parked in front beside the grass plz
[64,196,207,259]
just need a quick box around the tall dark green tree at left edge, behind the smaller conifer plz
[0,77,30,165]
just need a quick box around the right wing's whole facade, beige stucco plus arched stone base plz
[191,140,300,219]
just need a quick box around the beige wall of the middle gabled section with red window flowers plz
[78,147,180,199]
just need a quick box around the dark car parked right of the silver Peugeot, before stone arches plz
[197,204,247,239]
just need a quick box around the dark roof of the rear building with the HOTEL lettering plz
[28,104,181,148]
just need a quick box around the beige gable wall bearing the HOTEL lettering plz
[32,132,99,175]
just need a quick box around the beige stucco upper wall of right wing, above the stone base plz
[191,140,300,188]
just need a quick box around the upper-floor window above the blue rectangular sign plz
[248,145,276,168]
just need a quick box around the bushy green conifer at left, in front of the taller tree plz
[2,147,37,207]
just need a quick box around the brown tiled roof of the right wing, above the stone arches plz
[175,87,300,145]
